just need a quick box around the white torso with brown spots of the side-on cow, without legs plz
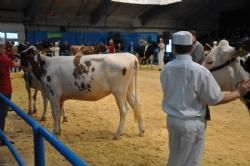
[44,53,137,101]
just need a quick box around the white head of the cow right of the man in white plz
[203,40,237,69]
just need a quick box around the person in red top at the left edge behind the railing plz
[0,38,20,145]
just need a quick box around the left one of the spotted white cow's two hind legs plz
[113,94,128,140]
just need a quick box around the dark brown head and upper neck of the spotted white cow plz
[18,45,46,80]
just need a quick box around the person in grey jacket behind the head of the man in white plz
[190,31,205,64]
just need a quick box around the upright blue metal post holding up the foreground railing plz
[33,128,45,166]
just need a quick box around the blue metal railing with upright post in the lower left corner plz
[0,93,87,166]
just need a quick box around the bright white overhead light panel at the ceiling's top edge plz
[111,0,182,5]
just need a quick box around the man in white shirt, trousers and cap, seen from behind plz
[160,31,250,166]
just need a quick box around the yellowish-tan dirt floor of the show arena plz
[0,69,250,166]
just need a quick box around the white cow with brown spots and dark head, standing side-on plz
[21,46,144,140]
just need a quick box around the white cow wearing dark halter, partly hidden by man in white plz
[203,40,250,113]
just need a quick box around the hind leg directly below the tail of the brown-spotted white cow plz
[127,90,144,137]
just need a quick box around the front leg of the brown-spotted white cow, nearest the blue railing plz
[50,97,61,135]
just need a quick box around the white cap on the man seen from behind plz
[173,31,193,46]
